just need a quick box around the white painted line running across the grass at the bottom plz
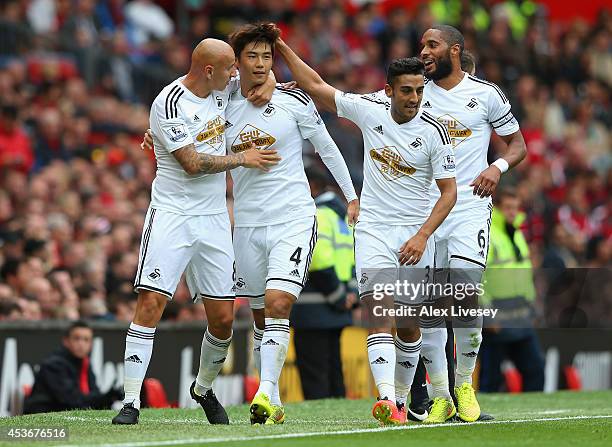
[56,414,612,447]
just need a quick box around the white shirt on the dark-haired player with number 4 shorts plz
[225,88,327,227]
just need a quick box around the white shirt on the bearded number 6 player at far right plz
[421,73,519,207]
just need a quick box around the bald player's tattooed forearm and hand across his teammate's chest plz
[172,144,280,175]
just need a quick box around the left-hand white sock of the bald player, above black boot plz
[123,323,155,409]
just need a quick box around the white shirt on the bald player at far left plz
[149,77,238,215]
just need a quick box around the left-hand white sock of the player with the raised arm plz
[367,332,395,399]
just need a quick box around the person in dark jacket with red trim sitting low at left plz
[24,321,122,414]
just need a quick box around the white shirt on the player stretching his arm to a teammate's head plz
[336,91,455,225]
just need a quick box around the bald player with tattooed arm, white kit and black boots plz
[112,39,280,425]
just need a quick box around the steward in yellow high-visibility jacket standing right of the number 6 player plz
[480,190,544,392]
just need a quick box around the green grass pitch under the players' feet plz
[0,391,612,447]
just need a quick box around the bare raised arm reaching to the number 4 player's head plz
[276,38,337,113]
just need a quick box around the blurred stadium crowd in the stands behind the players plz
[0,0,612,322]
